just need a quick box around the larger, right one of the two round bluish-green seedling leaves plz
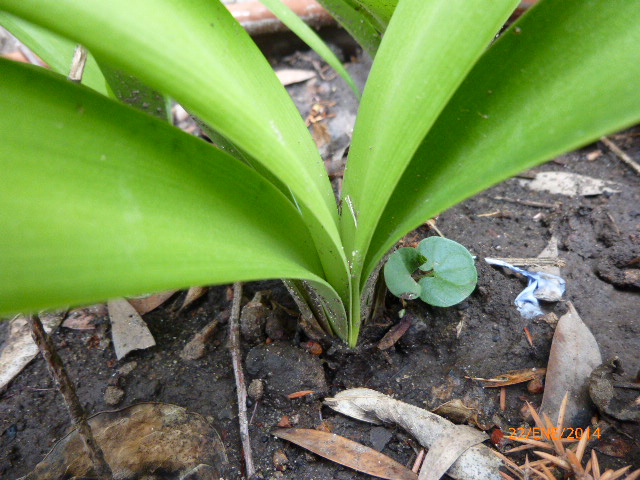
[417,237,478,307]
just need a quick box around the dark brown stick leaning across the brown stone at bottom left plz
[27,315,113,480]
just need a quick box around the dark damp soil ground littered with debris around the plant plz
[0,31,640,480]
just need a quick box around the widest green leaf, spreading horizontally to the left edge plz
[0,60,335,313]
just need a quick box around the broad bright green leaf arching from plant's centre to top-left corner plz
[0,0,350,301]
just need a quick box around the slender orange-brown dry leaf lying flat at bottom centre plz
[273,428,418,480]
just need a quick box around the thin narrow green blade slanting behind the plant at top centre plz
[260,0,360,98]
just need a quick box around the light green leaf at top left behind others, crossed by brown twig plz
[0,11,108,95]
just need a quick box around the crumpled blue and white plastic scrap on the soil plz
[484,258,567,319]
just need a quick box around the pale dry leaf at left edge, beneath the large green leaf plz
[0,311,67,390]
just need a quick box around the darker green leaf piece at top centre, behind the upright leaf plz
[318,0,383,58]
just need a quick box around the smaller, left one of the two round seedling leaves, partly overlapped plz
[384,247,426,300]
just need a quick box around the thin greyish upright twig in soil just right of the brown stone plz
[229,282,255,478]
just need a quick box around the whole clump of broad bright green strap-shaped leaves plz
[0,0,640,345]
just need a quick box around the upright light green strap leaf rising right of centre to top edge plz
[342,0,518,282]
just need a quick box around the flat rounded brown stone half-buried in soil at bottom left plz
[25,403,227,480]
